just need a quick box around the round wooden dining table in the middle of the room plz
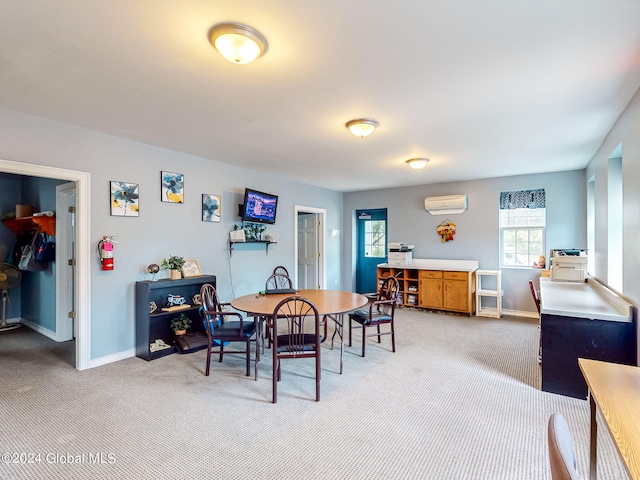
[231,290,368,373]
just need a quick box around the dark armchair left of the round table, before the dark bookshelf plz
[200,283,259,380]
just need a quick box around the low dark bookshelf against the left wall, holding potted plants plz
[136,275,216,361]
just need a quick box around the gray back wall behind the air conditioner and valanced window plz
[343,171,587,313]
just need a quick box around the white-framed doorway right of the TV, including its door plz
[294,205,327,290]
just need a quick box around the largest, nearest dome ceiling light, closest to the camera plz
[209,23,269,65]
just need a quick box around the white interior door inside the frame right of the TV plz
[298,213,320,290]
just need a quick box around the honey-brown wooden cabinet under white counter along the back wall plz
[378,267,475,315]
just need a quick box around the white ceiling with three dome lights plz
[0,0,640,191]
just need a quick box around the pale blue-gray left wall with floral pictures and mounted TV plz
[0,109,342,359]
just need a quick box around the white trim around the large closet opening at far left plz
[0,160,91,370]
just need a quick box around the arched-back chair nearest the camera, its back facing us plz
[269,296,322,403]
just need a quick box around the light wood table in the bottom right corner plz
[578,358,640,480]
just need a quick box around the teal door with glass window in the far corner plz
[356,208,387,293]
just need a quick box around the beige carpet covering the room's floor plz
[0,310,627,480]
